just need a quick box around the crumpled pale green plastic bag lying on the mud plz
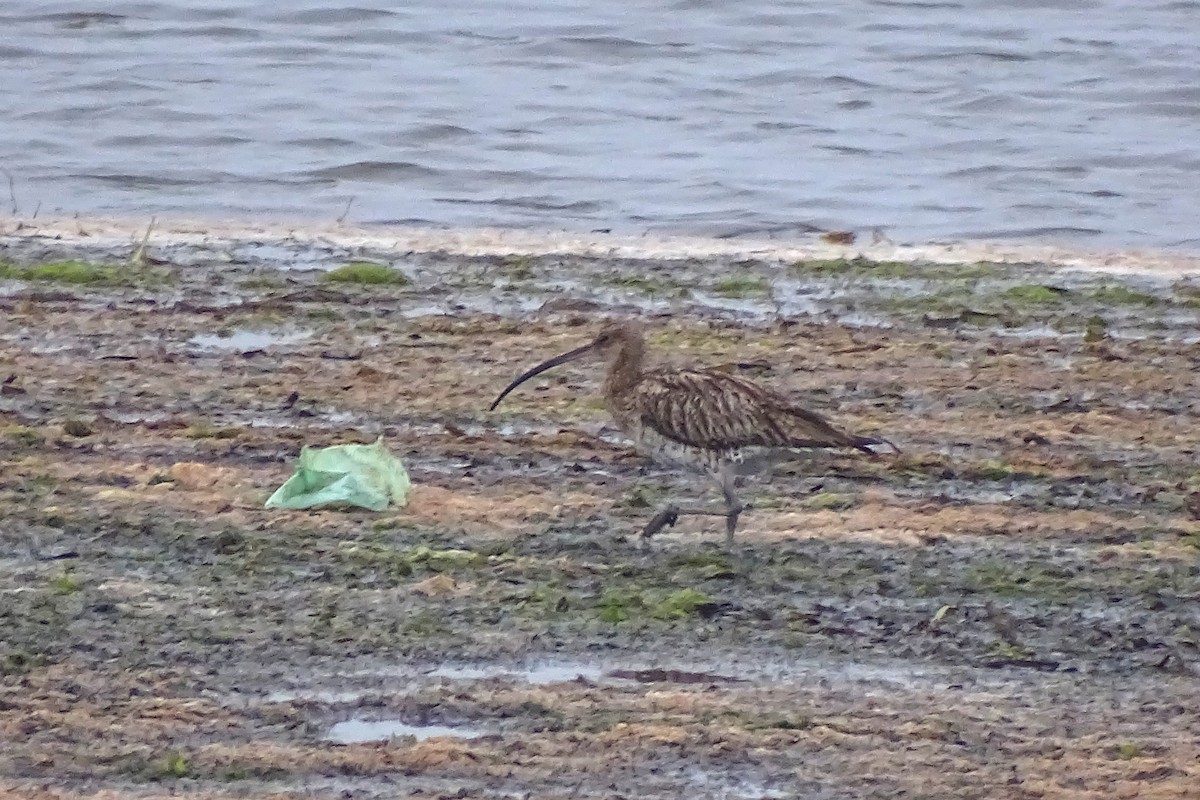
[266,437,412,511]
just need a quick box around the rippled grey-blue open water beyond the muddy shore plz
[0,0,1200,248]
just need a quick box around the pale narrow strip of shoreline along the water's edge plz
[7,216,1200,278]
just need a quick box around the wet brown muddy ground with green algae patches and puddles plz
[0,226,1200,799]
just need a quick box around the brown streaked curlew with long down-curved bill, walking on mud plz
[491,321,894,542]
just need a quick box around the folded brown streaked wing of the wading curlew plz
[629,368,870,451]
